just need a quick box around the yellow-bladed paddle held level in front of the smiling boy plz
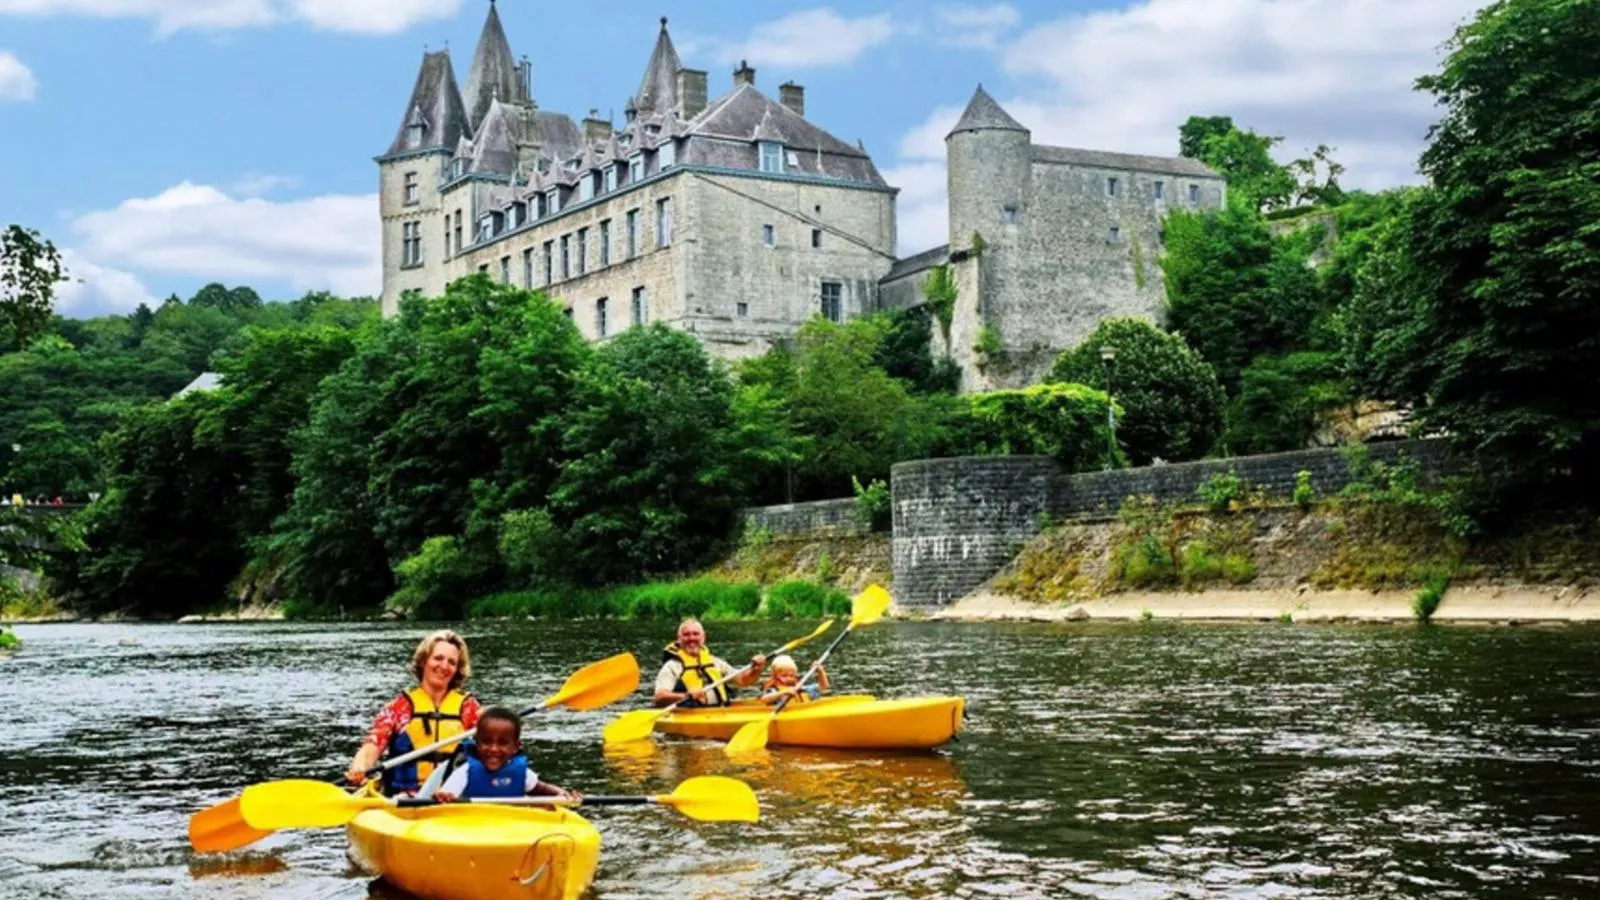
[240,775,762,830]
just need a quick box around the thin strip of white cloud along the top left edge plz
[0,0,461,35]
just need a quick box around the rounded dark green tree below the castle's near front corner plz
[549,323,746,585]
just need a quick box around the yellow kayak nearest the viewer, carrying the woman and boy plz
[346,804,600,900]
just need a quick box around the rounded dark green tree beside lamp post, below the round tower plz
[1048,319,1226,466]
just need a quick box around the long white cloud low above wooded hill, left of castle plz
[72,181,382,295]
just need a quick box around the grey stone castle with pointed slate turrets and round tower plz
[378,0,1222,389]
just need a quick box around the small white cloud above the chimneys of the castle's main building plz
[712,6,894,69]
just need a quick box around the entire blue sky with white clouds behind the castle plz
[0,0,1483,315]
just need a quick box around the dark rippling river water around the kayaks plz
[0,623,1600,900]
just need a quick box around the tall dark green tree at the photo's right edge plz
[1381,0,1600,498]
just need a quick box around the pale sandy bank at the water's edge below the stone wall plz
[928,586,1600,625]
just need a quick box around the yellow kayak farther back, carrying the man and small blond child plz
[656,695,966,749]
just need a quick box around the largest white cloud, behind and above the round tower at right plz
[890,0,1482,251]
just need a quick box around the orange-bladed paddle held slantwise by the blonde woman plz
[189,653,638,854]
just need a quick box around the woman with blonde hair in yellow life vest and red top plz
[344,629,483,796]
